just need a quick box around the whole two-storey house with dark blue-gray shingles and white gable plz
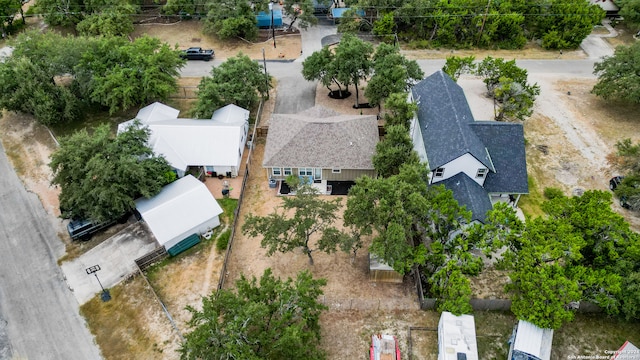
[409,71,529,222]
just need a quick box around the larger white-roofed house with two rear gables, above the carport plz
[118,102,249,176]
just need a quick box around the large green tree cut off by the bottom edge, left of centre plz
[180,269,327,360]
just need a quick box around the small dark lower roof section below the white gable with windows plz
[434,172,493,223]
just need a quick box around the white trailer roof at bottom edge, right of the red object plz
[438,311,478,360]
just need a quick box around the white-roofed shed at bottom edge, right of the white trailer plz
[507,320,553,360]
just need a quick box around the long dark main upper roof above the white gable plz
[411,70,494,171]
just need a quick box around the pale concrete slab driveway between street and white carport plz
[60,222,157,305]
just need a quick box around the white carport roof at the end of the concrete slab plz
[136,175,222,251]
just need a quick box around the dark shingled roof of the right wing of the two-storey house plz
[471,121,529,194]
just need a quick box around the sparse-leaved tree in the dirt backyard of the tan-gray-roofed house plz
[242,184,359,265]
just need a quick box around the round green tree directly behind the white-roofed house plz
[193,53,269,117]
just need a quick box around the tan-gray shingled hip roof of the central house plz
[262,107,378,170]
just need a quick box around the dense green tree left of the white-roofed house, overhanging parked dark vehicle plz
[49,123,175,221]
